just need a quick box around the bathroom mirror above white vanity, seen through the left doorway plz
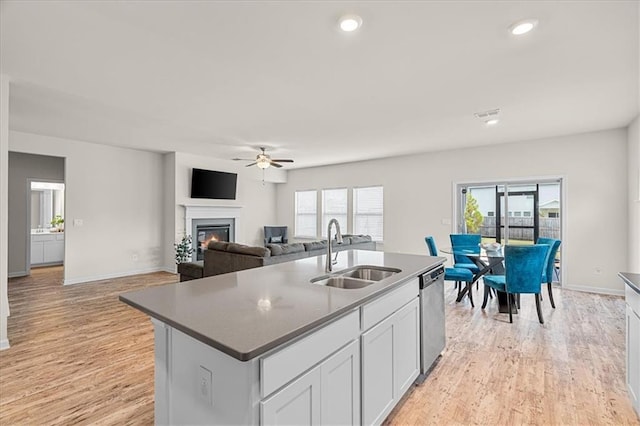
[31,182,64,232]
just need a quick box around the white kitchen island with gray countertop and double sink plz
[120,250,445,425]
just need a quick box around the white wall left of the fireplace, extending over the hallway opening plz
[9,131,164,284]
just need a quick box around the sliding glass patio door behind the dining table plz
[456,178,564,283]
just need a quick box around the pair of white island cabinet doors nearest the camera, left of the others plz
[260,340,360,425]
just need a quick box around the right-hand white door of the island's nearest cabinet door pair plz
[320,340,360,425]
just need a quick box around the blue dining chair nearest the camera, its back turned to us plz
[482,244,549,324]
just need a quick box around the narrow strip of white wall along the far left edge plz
[0,74,9,349]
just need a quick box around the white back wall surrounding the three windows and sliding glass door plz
[277,129,628,294]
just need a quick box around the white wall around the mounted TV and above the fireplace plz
[171,153,286,259]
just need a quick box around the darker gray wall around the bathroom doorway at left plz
[7,152,64,276]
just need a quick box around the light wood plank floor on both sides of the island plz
[0,268,640,426]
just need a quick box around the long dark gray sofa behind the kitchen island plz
[178,235,376,281]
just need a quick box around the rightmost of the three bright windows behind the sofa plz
[353,186,384,241]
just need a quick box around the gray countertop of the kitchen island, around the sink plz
[120,250,445,361]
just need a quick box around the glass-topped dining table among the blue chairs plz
[440,247,517,313]
